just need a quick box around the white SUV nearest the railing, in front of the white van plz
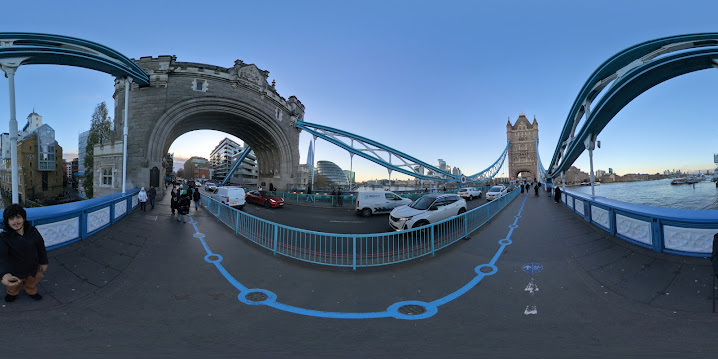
[389,194,466,231]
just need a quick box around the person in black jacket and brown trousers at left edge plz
[0,204,48,303]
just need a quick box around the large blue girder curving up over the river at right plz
[548,33,718,178]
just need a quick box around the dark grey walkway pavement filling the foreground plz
[0,191,718,358]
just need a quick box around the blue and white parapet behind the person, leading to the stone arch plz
[0,189,140,249]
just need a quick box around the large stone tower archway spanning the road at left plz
[96,56,304,197]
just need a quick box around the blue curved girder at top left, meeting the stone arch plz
[0,32,150,87]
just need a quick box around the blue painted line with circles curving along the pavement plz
[188,197,528,320]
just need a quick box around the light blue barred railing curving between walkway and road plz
[202,191,520,269]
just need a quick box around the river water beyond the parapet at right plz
[566,179,718,210]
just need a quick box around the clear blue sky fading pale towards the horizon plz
[0,0,718,181]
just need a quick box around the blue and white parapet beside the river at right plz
[561,191,718,257]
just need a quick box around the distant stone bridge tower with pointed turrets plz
[506,113,538,179]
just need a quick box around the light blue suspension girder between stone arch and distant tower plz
[296,120,509,183]
